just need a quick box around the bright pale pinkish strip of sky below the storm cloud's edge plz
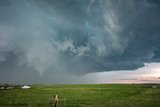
[83,63,160,83]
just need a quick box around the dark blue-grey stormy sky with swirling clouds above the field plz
[0,0,160,84]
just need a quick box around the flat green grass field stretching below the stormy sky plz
[0,84,160,107]
